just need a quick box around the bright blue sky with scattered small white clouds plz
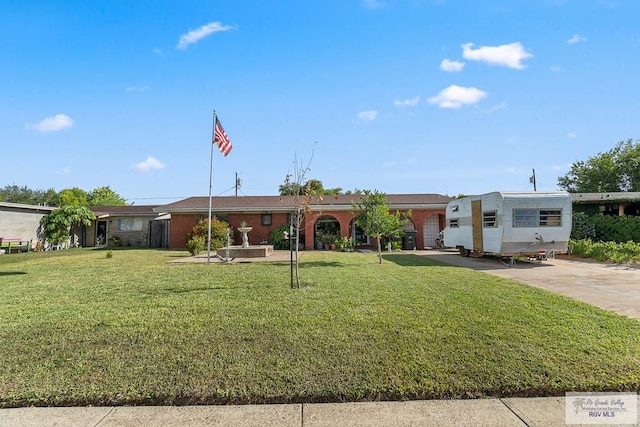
[0,0,640,204]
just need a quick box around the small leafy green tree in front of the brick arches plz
[352,190,411,264]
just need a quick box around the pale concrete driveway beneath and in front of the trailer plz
[419,250,640,319]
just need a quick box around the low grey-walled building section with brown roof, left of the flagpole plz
[84,205,169,248]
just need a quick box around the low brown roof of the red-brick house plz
[154,194,451,213]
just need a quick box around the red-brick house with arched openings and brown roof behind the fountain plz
[154,194,451,250]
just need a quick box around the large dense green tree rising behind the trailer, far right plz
[558,139,640,193]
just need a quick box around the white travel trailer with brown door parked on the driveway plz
[444,191,572,260]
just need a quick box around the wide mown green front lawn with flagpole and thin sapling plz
[0,249,640,406]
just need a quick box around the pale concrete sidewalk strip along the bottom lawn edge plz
[0,397,604,427]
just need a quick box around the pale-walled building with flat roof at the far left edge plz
[0,202,55,246]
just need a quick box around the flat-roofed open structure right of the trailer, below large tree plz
[571,192,640,216]
